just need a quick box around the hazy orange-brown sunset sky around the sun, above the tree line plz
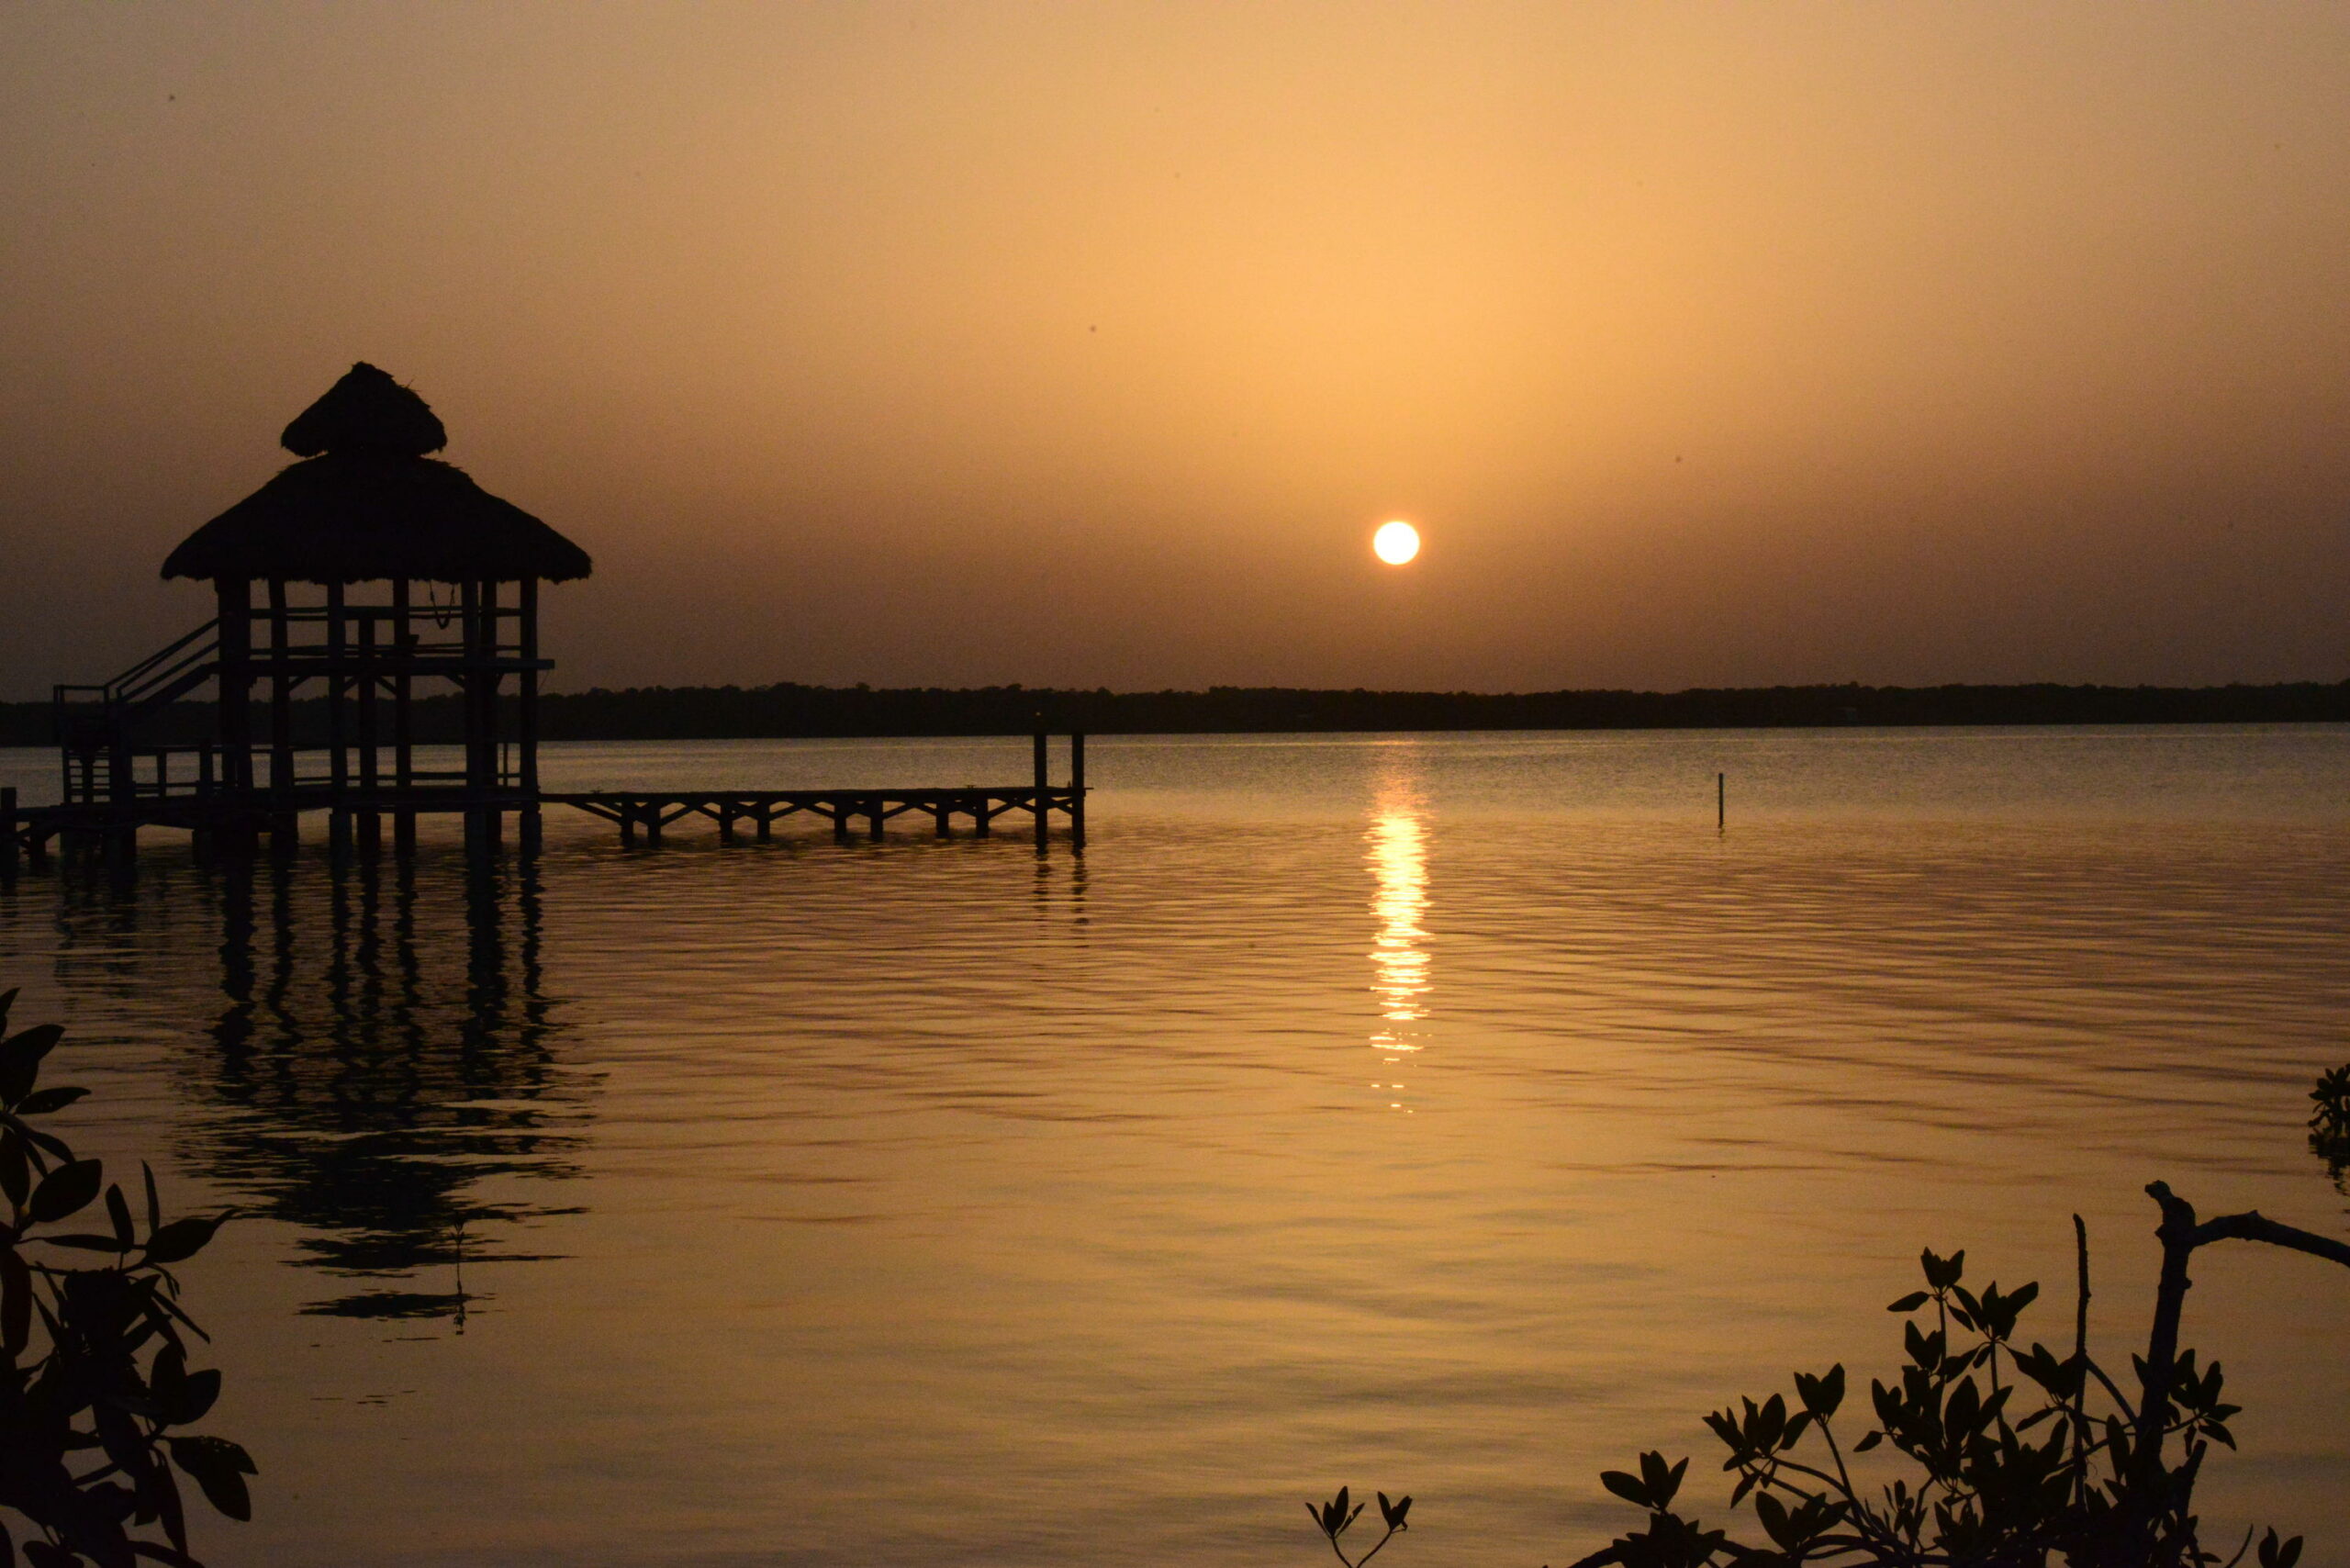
[0,0,2350,696]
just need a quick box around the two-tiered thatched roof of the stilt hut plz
[162,364,590,583]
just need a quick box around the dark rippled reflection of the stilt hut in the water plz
[72,854,585,1328]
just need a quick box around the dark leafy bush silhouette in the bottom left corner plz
[0,992,253,1568]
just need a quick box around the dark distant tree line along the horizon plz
[0,682,2350,745]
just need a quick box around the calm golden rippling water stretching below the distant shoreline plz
[0,729,2350,1568]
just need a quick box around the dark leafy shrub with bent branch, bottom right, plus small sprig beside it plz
[1309,1189,2350,1568]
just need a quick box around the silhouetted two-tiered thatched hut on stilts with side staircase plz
[56,364,592,848]
